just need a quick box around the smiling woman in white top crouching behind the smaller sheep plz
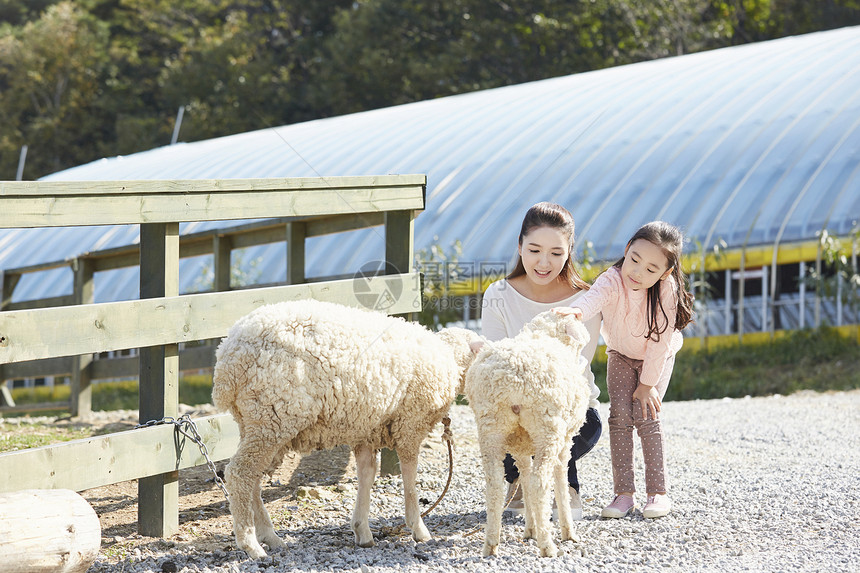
[481,203,602,519]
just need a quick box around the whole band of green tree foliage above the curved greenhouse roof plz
[0,0,860,179]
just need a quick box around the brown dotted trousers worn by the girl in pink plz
[606,350,675,494]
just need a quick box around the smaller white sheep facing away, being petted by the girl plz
[466,311,591,557]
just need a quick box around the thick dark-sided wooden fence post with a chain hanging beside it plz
[137,223,179,537]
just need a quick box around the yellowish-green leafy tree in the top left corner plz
[0,2,109,178]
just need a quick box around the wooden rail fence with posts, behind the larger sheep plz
[0,175,427,537]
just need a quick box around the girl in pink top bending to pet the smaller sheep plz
[556,221,693,518]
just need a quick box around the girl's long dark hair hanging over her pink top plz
[612,221,693,342]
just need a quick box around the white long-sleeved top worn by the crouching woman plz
[481,279,601,408]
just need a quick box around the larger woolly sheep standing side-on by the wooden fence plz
[212,300,478,558]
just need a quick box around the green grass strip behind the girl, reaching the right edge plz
[592,327,860,401]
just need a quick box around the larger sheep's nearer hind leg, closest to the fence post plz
[224,436,277,559]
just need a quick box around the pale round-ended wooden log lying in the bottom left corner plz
[0,489,101,573]
